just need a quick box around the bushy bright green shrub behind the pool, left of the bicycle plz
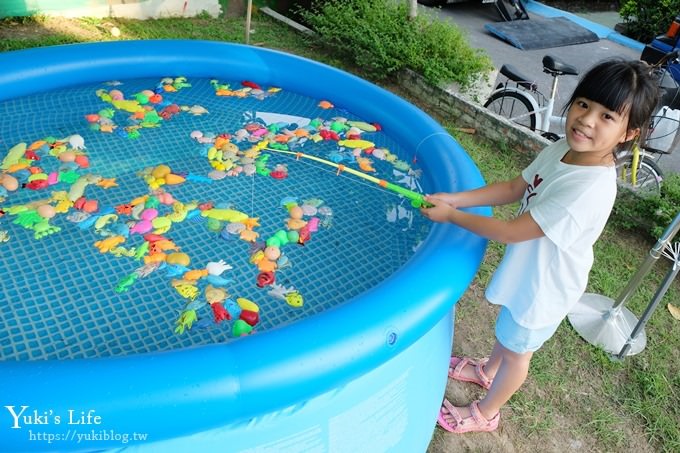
[299,0,491,87]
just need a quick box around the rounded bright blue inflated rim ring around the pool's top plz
[0,40,490,444]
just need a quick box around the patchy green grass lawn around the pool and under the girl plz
[0,10,680,453]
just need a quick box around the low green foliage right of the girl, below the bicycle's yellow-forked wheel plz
[612,174,680,239]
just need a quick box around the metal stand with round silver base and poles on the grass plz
[568,212,680,360]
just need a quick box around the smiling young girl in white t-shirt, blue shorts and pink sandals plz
[421,60,658,433]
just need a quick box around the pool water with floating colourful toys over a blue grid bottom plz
[0,77,429,360]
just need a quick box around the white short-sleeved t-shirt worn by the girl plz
[486,140,616,329]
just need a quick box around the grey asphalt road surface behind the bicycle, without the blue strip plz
[422,1,680,173]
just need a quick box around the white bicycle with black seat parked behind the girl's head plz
[484,52,680,194]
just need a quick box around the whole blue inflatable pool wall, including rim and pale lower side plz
[0,40,489,452]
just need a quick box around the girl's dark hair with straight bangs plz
[564,59,659,132]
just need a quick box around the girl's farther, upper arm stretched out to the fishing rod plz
[425,175,527,208]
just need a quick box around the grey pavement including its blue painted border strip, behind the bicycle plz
[422,0,680,173]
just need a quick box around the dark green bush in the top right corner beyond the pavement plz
[619,0,680,42]
